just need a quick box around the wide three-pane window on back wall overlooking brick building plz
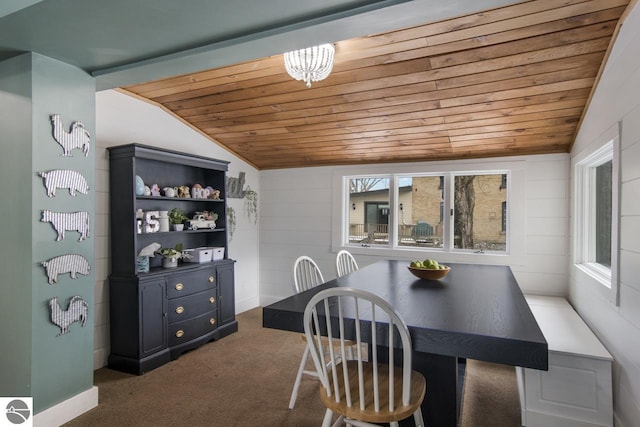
[342,171,508,253]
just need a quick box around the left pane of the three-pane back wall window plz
[349,177,389,245]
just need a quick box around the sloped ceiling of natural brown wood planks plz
[124,0,629,169]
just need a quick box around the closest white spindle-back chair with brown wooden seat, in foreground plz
[304,287,426,427]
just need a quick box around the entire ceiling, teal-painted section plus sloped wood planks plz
[0,0,636,169]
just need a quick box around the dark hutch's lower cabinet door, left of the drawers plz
[139,278,167,356]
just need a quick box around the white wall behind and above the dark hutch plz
[94,91,260,369]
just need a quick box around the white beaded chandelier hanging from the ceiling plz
[284,44,335,88]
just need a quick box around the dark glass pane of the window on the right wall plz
[595,160,612,268]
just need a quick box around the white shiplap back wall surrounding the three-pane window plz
[260,154,569,305]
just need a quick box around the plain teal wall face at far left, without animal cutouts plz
[0,52,33,396]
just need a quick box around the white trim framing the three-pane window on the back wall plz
[331,158,527,265]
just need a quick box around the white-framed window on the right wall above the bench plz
[574,137,618,300]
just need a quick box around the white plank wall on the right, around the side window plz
[570,5,640,427]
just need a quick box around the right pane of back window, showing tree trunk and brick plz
[453,174,508,251]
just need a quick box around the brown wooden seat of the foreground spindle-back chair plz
[320,361,427,423]
